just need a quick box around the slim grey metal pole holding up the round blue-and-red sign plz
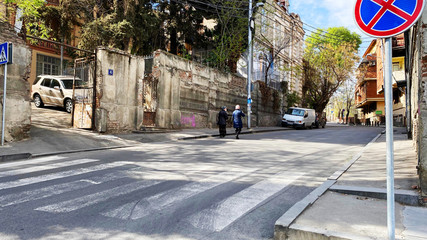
[384,38,395,240]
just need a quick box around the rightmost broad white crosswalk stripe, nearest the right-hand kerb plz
[188,171,304,232]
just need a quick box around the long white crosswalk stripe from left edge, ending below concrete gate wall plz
[0,161,133,190]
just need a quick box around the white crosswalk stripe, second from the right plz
[102,169,255,220]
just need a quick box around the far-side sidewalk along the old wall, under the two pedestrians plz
[0,125,289,162]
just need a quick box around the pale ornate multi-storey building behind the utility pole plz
[237,0,305,96]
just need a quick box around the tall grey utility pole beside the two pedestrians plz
[247,0,264,129]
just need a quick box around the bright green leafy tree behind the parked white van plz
[302,27,362,115]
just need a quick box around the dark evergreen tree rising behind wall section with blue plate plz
[79,0,165,55]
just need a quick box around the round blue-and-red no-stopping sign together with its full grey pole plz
[354,0,425,240]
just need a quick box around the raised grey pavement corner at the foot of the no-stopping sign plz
[288,192,404,239]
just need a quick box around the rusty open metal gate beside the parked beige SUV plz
[72,56,96,129]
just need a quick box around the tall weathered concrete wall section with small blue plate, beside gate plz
[95,48,144,132]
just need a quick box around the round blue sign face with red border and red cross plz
[354,0,425,38]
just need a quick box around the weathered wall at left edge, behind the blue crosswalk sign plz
[0,23,31,142]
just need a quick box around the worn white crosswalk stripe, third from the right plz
[35,180,162,213]
